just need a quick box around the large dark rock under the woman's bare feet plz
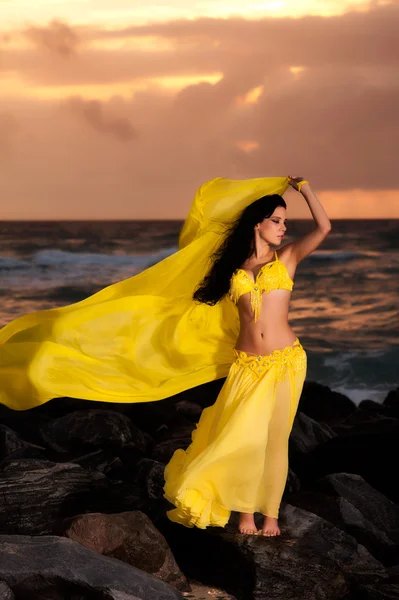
[161,503,388,600]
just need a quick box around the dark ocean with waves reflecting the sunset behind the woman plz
[0,219,399,404]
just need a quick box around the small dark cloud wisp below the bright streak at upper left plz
[65,98,138,142]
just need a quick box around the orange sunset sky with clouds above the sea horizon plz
[0,0,399,220]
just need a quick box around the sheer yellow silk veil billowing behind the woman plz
[0,177,288,410]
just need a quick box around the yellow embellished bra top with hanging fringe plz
[229,250,294,321]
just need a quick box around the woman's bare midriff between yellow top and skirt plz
[235,290,297,356]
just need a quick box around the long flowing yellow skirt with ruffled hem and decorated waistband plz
[164,338,307,529]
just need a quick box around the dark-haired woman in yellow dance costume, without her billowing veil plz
[164,176,331,536]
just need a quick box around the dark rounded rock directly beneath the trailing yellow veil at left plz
[40,409,151,453]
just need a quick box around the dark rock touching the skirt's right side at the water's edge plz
[298,381,356,425]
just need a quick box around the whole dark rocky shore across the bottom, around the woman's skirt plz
[0,380,399,600]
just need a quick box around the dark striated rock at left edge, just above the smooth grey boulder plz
[0,459,143,534]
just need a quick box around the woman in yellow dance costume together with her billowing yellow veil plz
[0,172,330,535]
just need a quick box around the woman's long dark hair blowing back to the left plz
[193,194,287,305]
